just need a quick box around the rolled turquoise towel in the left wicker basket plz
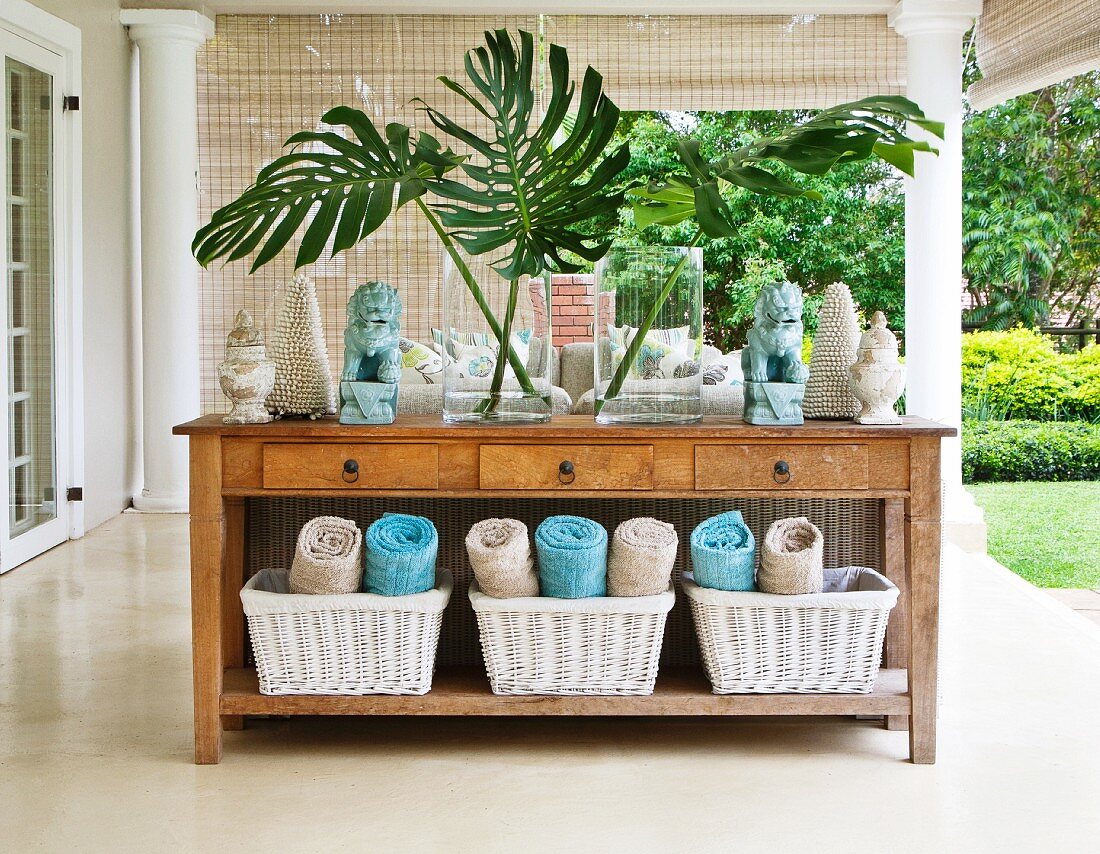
[363,513,439,596]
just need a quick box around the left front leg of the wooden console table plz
[190,436,226,765]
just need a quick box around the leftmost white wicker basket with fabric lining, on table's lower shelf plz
[241,569,452,694]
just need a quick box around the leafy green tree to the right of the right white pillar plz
[963,63,1100,329]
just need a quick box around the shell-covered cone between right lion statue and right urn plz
[802,282,859,418]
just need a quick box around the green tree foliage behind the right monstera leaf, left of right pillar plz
[589,110,904,350]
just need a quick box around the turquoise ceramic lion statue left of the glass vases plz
[340,282,402,383]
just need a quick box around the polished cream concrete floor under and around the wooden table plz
[0,515,1100,854]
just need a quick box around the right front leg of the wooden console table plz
[905,438,942,765]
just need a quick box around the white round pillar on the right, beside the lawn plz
[889,0,985,550]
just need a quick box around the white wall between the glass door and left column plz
[32,0,140,530]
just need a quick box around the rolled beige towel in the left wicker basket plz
[289,516,363,595]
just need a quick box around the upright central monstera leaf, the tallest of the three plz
[425,30,630,281]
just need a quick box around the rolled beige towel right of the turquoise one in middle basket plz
[607,517,679,596]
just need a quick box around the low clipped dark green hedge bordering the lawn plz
[963,421,1100,483]
